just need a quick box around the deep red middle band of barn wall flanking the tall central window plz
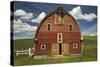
[37,31,80,43]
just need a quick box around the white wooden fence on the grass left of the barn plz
[16,48,34,57]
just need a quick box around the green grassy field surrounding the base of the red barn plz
[14,36,97,65]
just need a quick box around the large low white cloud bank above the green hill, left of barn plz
[13,19,37,39]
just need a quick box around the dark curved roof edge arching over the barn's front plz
[35,7,77,38]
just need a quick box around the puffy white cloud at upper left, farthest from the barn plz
[14,9,33,20]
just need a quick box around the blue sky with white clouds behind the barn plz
[11,1,97,39]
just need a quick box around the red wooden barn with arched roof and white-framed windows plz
[35,7,83,55]
